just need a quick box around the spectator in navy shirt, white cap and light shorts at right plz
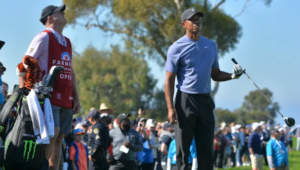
[248,122,263,170]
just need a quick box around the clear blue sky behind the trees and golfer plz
[0,0,300,124]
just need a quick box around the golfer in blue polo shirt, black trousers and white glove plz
[165,8,244,170]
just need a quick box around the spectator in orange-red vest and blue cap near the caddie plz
[69,128,88,170]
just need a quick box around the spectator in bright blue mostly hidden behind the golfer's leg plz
[167,139,198,170]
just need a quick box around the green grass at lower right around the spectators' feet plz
[227,138,300,170]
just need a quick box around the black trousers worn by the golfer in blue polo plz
[175,90,215,170]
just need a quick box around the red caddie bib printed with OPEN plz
[44,30,73,109]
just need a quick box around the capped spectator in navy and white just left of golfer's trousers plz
[160,122,174,170]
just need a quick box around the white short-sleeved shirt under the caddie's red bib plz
[25,28,67,74]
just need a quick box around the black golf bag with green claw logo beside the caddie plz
[0,66,64,170]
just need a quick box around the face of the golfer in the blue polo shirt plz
[181,14,202,34]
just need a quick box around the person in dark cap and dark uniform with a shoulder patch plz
[88,110,110,170]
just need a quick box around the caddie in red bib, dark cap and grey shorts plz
[20,5,80,170]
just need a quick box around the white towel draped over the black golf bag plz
[27,89,54,144]
